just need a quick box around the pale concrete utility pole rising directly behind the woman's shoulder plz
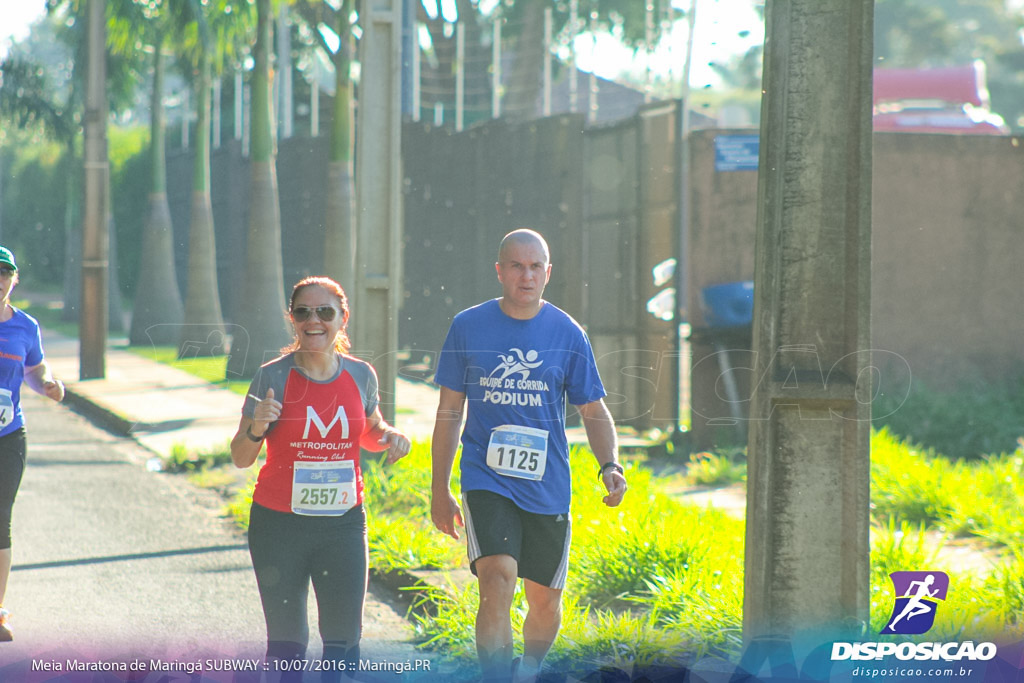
[349,0,403,423]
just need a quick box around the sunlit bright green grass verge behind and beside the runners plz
[163,431,1024,671]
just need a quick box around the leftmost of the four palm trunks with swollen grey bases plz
[128,36,183,346]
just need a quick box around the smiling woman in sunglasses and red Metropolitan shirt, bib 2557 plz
[231,278,410,680]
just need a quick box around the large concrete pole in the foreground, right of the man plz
[743,0,873,645]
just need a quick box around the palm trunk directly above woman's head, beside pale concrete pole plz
[323,0,355,288]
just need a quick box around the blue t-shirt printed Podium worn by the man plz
[434,299,605,515]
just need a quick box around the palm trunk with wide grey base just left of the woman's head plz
[227,0,289,379]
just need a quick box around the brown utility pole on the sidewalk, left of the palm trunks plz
[79,0,110,380]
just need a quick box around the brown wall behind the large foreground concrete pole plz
[687,130,1024,447]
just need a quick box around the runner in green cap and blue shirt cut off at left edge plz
[0,247,63,641]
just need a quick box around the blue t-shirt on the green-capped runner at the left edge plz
[0,308,43,436]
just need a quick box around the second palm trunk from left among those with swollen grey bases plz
[177,41,226,357]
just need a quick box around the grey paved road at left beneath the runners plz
[0,391,438,681]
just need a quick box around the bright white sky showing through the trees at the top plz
[0,0,764,88]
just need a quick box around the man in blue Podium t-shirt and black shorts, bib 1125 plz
[431,229,627,681]
